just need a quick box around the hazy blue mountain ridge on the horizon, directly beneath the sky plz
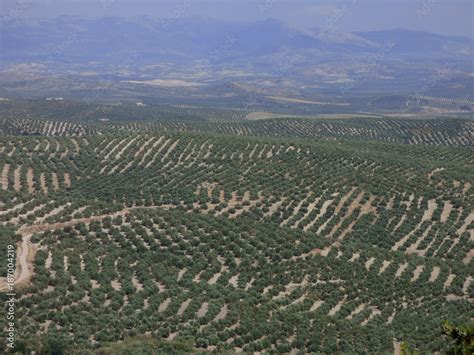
[0,16,474,65]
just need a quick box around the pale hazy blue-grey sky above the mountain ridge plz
[0,0,474,37]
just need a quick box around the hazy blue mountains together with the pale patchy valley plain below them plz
[0,16,474,109]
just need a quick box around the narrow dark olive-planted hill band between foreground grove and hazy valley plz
[0,100,474,147]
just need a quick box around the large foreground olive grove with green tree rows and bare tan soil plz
[0,114,474,354]
